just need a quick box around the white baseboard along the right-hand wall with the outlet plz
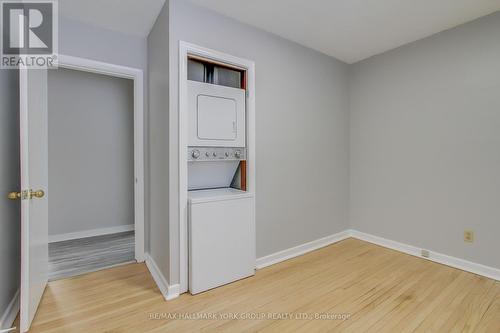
[349,230,500,281]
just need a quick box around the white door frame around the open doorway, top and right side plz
[57,55,145,262]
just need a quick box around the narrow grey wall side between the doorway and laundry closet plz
[148,1,172,278]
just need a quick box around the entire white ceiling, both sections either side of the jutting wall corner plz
[59,0,500,63]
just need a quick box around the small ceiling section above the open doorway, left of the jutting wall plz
[59,0,165,37]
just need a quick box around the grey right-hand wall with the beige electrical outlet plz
[350,13,500,267]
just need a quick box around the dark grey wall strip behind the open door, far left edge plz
[0,69,21,327]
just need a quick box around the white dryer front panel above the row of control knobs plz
[188,81,245,147]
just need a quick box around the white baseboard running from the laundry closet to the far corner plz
[256,230,350,269]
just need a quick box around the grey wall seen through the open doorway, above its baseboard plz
[48,69,134,235]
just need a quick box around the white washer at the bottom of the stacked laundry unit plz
[188,188,256,294]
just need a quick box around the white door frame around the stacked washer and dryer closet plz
[178,40,256,293]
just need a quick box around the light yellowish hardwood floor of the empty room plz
[24,239,500,333]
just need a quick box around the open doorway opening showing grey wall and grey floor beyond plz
[48,68,135,280]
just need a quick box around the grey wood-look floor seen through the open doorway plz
[49,231,135,280]
